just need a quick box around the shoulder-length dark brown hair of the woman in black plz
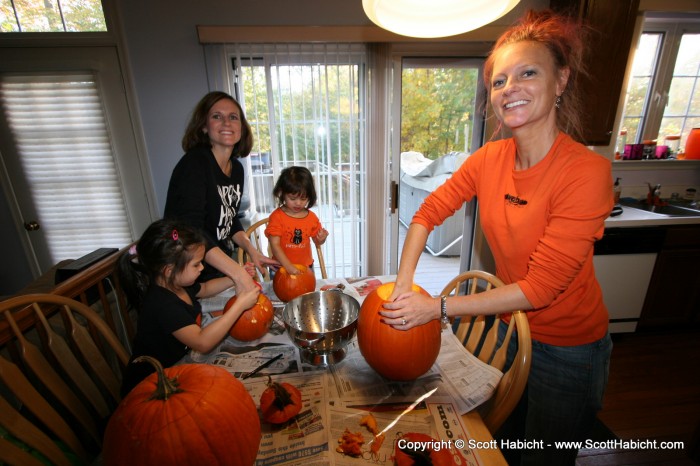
[182,91,253,158]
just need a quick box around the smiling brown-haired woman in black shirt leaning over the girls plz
[164,91,278,289]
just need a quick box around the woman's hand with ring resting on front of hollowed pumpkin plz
[379,291,440,330]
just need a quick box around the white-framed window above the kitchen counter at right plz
[620,18,700,148]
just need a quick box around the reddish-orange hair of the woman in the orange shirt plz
[484,9,592,137]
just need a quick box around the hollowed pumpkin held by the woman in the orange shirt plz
[357,283,441,380]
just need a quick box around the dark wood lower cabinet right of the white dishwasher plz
[639,225,700,329]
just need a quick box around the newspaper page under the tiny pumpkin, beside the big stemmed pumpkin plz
[243,373,330,466]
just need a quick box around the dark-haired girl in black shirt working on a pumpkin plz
[117,220,259,395]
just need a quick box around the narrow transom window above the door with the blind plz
[0,0,107,32]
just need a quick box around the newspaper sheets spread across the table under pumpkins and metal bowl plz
[188,276,502,466]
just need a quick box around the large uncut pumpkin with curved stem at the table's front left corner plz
[102,356,261,466]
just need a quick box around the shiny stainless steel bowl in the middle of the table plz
[282,289,360,365]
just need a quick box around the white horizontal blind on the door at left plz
[0,72,131,263]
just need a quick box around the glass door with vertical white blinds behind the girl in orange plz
[233,44,367,277]
